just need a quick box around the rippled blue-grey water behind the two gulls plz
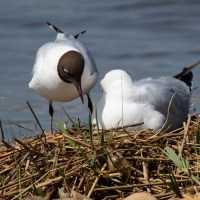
[0,0,200,136]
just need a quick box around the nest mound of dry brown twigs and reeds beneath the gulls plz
[0,116,200,200]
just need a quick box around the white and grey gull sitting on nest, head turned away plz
[93,62,200,131]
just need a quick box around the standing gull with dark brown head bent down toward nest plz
[29,23,99,133]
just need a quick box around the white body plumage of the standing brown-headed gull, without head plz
[29,32,99,102]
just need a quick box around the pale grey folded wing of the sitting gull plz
[134,77,190,116]
